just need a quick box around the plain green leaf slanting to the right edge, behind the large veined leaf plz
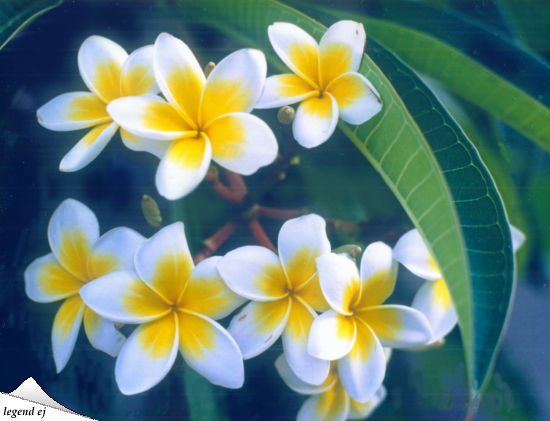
[354,15,550,151]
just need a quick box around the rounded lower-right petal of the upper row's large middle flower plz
[205,112,279,175]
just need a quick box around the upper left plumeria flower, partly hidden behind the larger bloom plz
[36,35,166,171]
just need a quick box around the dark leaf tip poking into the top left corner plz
[0,0,63,48]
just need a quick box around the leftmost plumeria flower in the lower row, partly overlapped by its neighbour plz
[25,199,145,373]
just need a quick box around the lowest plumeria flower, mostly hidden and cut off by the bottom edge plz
[275,355,386,421]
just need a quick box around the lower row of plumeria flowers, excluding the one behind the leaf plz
[25,199,432,420]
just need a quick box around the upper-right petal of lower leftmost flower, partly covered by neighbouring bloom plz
[87,227,146,279]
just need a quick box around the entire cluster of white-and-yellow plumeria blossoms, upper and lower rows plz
[25,16,523,421]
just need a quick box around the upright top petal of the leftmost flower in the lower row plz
[48,199,99,281]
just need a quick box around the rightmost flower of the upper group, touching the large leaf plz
[256,21,382,148]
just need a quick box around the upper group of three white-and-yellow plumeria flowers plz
[37,21,382,200]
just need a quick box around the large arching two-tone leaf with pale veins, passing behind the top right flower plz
[185,0,513,400]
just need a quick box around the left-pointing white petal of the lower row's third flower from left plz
[218,246,288,301]
